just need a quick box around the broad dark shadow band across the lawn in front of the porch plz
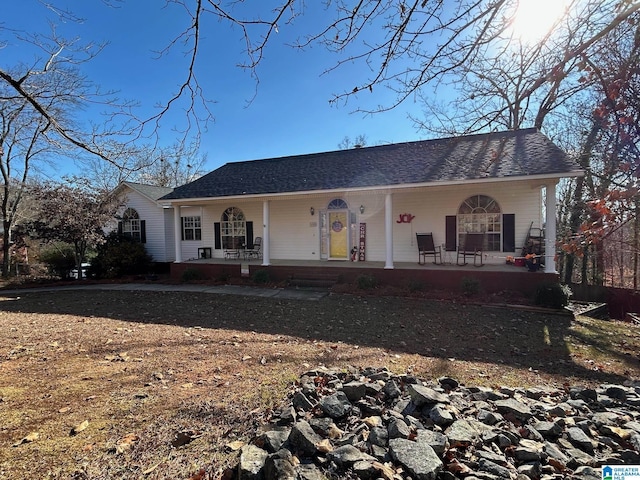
[0,291,640,383]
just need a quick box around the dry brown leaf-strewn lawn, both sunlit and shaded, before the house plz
[0,291,640,479]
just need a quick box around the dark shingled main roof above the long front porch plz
[162,129,580,200]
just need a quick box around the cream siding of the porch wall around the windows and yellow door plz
[170,181,542,263]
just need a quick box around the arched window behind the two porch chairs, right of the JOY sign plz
[458,195,502,251]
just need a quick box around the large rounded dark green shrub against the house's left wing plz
[89,232,151,278]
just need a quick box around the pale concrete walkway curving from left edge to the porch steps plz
[0,283,329,301]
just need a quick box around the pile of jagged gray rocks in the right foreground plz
[236,368,640,480]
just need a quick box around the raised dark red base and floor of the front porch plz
[171,252,559,296]
